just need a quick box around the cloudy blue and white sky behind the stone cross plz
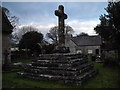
[2,2,108,36]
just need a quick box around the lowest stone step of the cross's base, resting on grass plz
[18,69,97,85]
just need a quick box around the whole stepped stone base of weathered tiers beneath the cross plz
[18,54,98,85]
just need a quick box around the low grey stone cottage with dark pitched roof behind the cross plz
[65,35,102,54]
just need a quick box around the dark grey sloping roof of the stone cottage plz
[71,35,102,46]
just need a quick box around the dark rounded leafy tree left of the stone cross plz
[19,31,43,50]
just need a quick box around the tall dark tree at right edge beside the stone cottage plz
[94,1,120,50]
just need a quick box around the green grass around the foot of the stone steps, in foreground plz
[2,63,120,88]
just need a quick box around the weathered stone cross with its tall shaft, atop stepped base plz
[55,5,67,46]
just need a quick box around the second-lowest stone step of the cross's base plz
[25,64,93,76]
